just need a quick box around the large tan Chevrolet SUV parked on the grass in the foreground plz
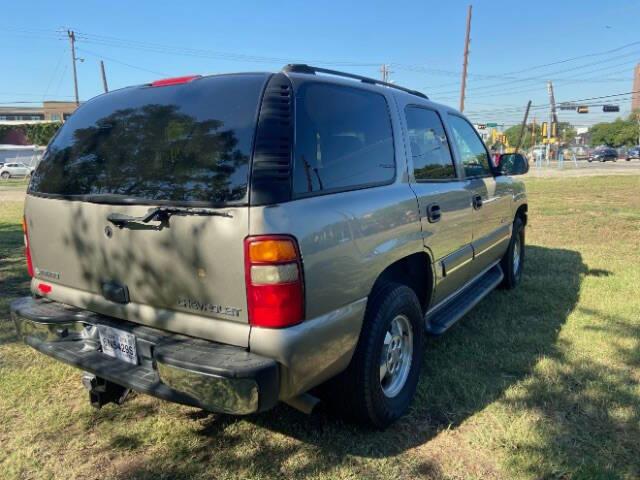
[11,65,528,428]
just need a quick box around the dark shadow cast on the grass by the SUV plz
[106,246,624,478]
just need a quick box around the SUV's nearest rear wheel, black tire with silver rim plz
[327,283,424,429]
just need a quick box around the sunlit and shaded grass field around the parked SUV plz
[0,176,640,479]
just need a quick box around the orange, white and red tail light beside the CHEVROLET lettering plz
[244,235,304,328]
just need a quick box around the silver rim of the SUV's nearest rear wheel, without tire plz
[380,315,413,398]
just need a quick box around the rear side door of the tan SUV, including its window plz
[404,105,473,304]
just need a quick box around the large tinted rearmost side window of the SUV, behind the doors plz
[293,83,395,194]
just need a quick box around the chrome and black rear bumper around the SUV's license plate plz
[11,297,280,414]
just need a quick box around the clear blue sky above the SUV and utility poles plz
[0,0,640,126]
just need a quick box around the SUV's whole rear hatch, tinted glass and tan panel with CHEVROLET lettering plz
[25,74,268,344]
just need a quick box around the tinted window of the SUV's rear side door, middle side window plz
[405,107,456,181]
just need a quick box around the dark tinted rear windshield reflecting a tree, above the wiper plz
[30,74,268,204]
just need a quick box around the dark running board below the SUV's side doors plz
[425,264,504,335]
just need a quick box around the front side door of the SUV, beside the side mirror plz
[448,113,513,274]
